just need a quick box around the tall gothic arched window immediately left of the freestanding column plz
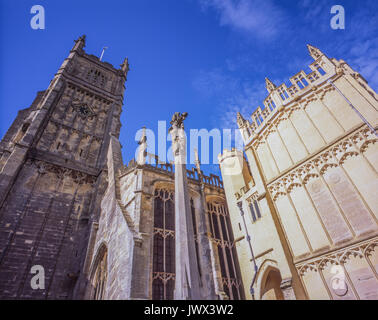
[152,189,175,300]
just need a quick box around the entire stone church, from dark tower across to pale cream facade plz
[0,36,378,300]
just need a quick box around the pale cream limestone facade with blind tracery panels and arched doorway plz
[219,46,378,299]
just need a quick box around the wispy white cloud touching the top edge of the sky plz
[199,0,286,39]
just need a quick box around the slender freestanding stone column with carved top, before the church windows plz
[169,112,202,300]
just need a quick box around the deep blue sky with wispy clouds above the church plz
[0,0,378,172]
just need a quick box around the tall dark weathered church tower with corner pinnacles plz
[0,36,129,299]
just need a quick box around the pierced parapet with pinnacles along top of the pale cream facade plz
[237,45,335,140]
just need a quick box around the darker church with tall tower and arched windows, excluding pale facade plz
[0,36,245,299]
